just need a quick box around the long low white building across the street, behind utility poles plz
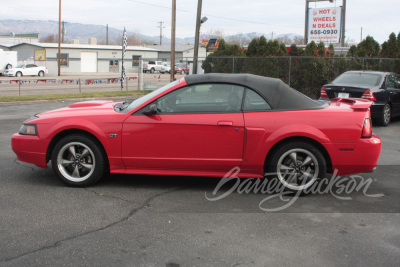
[3,43,206,76]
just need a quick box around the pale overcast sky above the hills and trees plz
[0,0,400,43]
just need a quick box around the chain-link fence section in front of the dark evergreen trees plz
[202,57,400,98]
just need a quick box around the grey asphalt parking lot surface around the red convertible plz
[0,99,400,266]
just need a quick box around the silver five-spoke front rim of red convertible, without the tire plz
[57,142,95,182]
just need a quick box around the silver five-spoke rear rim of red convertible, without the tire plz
[277,148,319,191]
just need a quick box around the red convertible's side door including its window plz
[122,82,245,172]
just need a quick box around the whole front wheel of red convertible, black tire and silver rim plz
[51,134,108,187]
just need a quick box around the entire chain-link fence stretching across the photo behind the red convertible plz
[0,56,400,98]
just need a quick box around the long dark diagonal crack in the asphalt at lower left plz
[0,187,184,263]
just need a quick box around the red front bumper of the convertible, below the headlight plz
[11,133,48,168]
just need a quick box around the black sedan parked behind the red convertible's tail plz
[319,71,400,126]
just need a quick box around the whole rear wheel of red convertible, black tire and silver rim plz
[266,142,326,193]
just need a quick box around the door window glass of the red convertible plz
[157,84,244,114]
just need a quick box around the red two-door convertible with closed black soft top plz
[12,74,381,191]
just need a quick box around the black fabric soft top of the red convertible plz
[185,73,325,110]
